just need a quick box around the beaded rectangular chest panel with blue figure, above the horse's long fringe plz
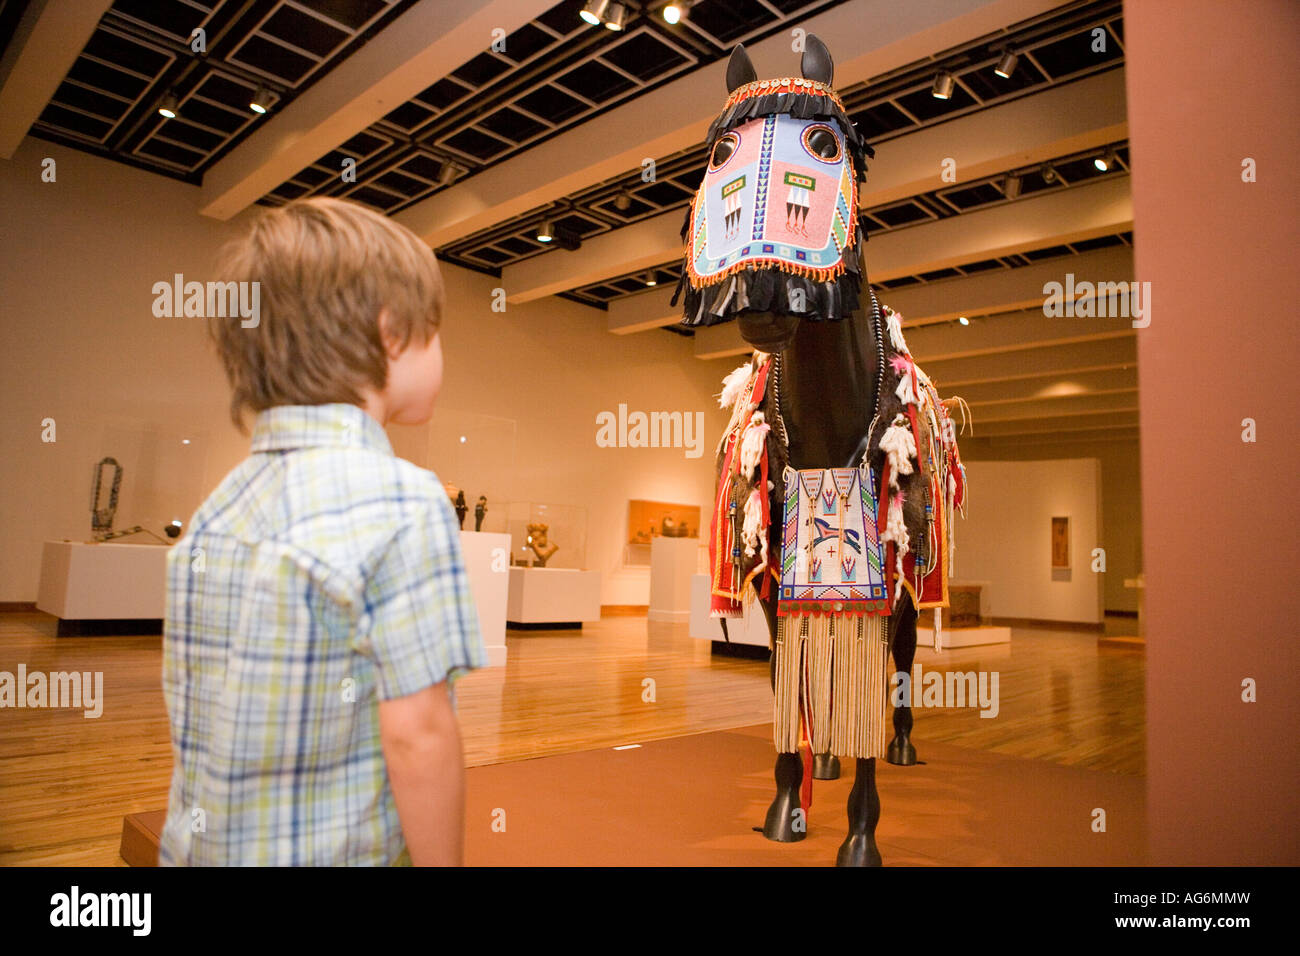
[777,467,888,614]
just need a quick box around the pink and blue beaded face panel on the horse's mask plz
[688,114,857,282]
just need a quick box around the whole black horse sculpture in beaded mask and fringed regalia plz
[673,35,966,866]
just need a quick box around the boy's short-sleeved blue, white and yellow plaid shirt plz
[160,405,488,866]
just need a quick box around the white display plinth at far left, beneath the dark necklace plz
[36,541,170,620]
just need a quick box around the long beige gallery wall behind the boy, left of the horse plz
[0,138,737,605]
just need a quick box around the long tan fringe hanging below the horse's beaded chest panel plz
[772,614,889,760]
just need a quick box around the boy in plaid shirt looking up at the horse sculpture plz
[160,199,486,866]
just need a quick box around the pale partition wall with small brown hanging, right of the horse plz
[954,458,1102,623]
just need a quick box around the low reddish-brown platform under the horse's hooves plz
[122,724,1145,866]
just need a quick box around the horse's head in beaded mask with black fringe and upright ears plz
[673,35,874,325]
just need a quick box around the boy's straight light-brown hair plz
[209,198,443,429]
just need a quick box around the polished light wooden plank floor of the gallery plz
[0,613,1145,866]
